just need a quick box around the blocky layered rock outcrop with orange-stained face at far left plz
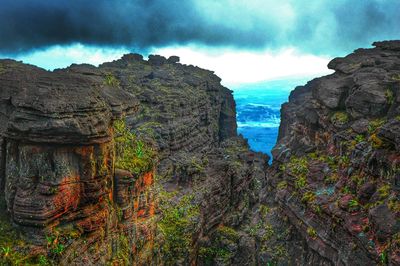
[0,61,137,233]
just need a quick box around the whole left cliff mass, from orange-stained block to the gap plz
[0,54,268,265]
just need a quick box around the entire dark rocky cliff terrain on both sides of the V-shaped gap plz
[0,41,400,265]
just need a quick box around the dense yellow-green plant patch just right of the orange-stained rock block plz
[114,120,156,173]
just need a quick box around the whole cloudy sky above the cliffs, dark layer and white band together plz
[0,0,400,85]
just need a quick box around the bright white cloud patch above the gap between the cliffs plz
[153,46,332,86]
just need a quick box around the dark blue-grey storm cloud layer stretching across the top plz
[0,0,400,54]
